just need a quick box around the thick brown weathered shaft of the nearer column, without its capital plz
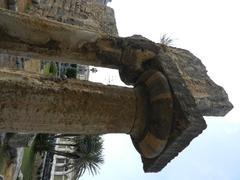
[0,70,136,134]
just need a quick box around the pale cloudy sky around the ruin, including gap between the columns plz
[81,0,240,180]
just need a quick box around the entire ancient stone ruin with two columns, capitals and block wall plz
[0,0,233,175]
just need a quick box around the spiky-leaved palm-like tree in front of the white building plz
[36,134,104,179]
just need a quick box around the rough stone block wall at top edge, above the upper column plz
[27,0,118,36]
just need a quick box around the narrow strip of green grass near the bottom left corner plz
[21,143,35,180]
